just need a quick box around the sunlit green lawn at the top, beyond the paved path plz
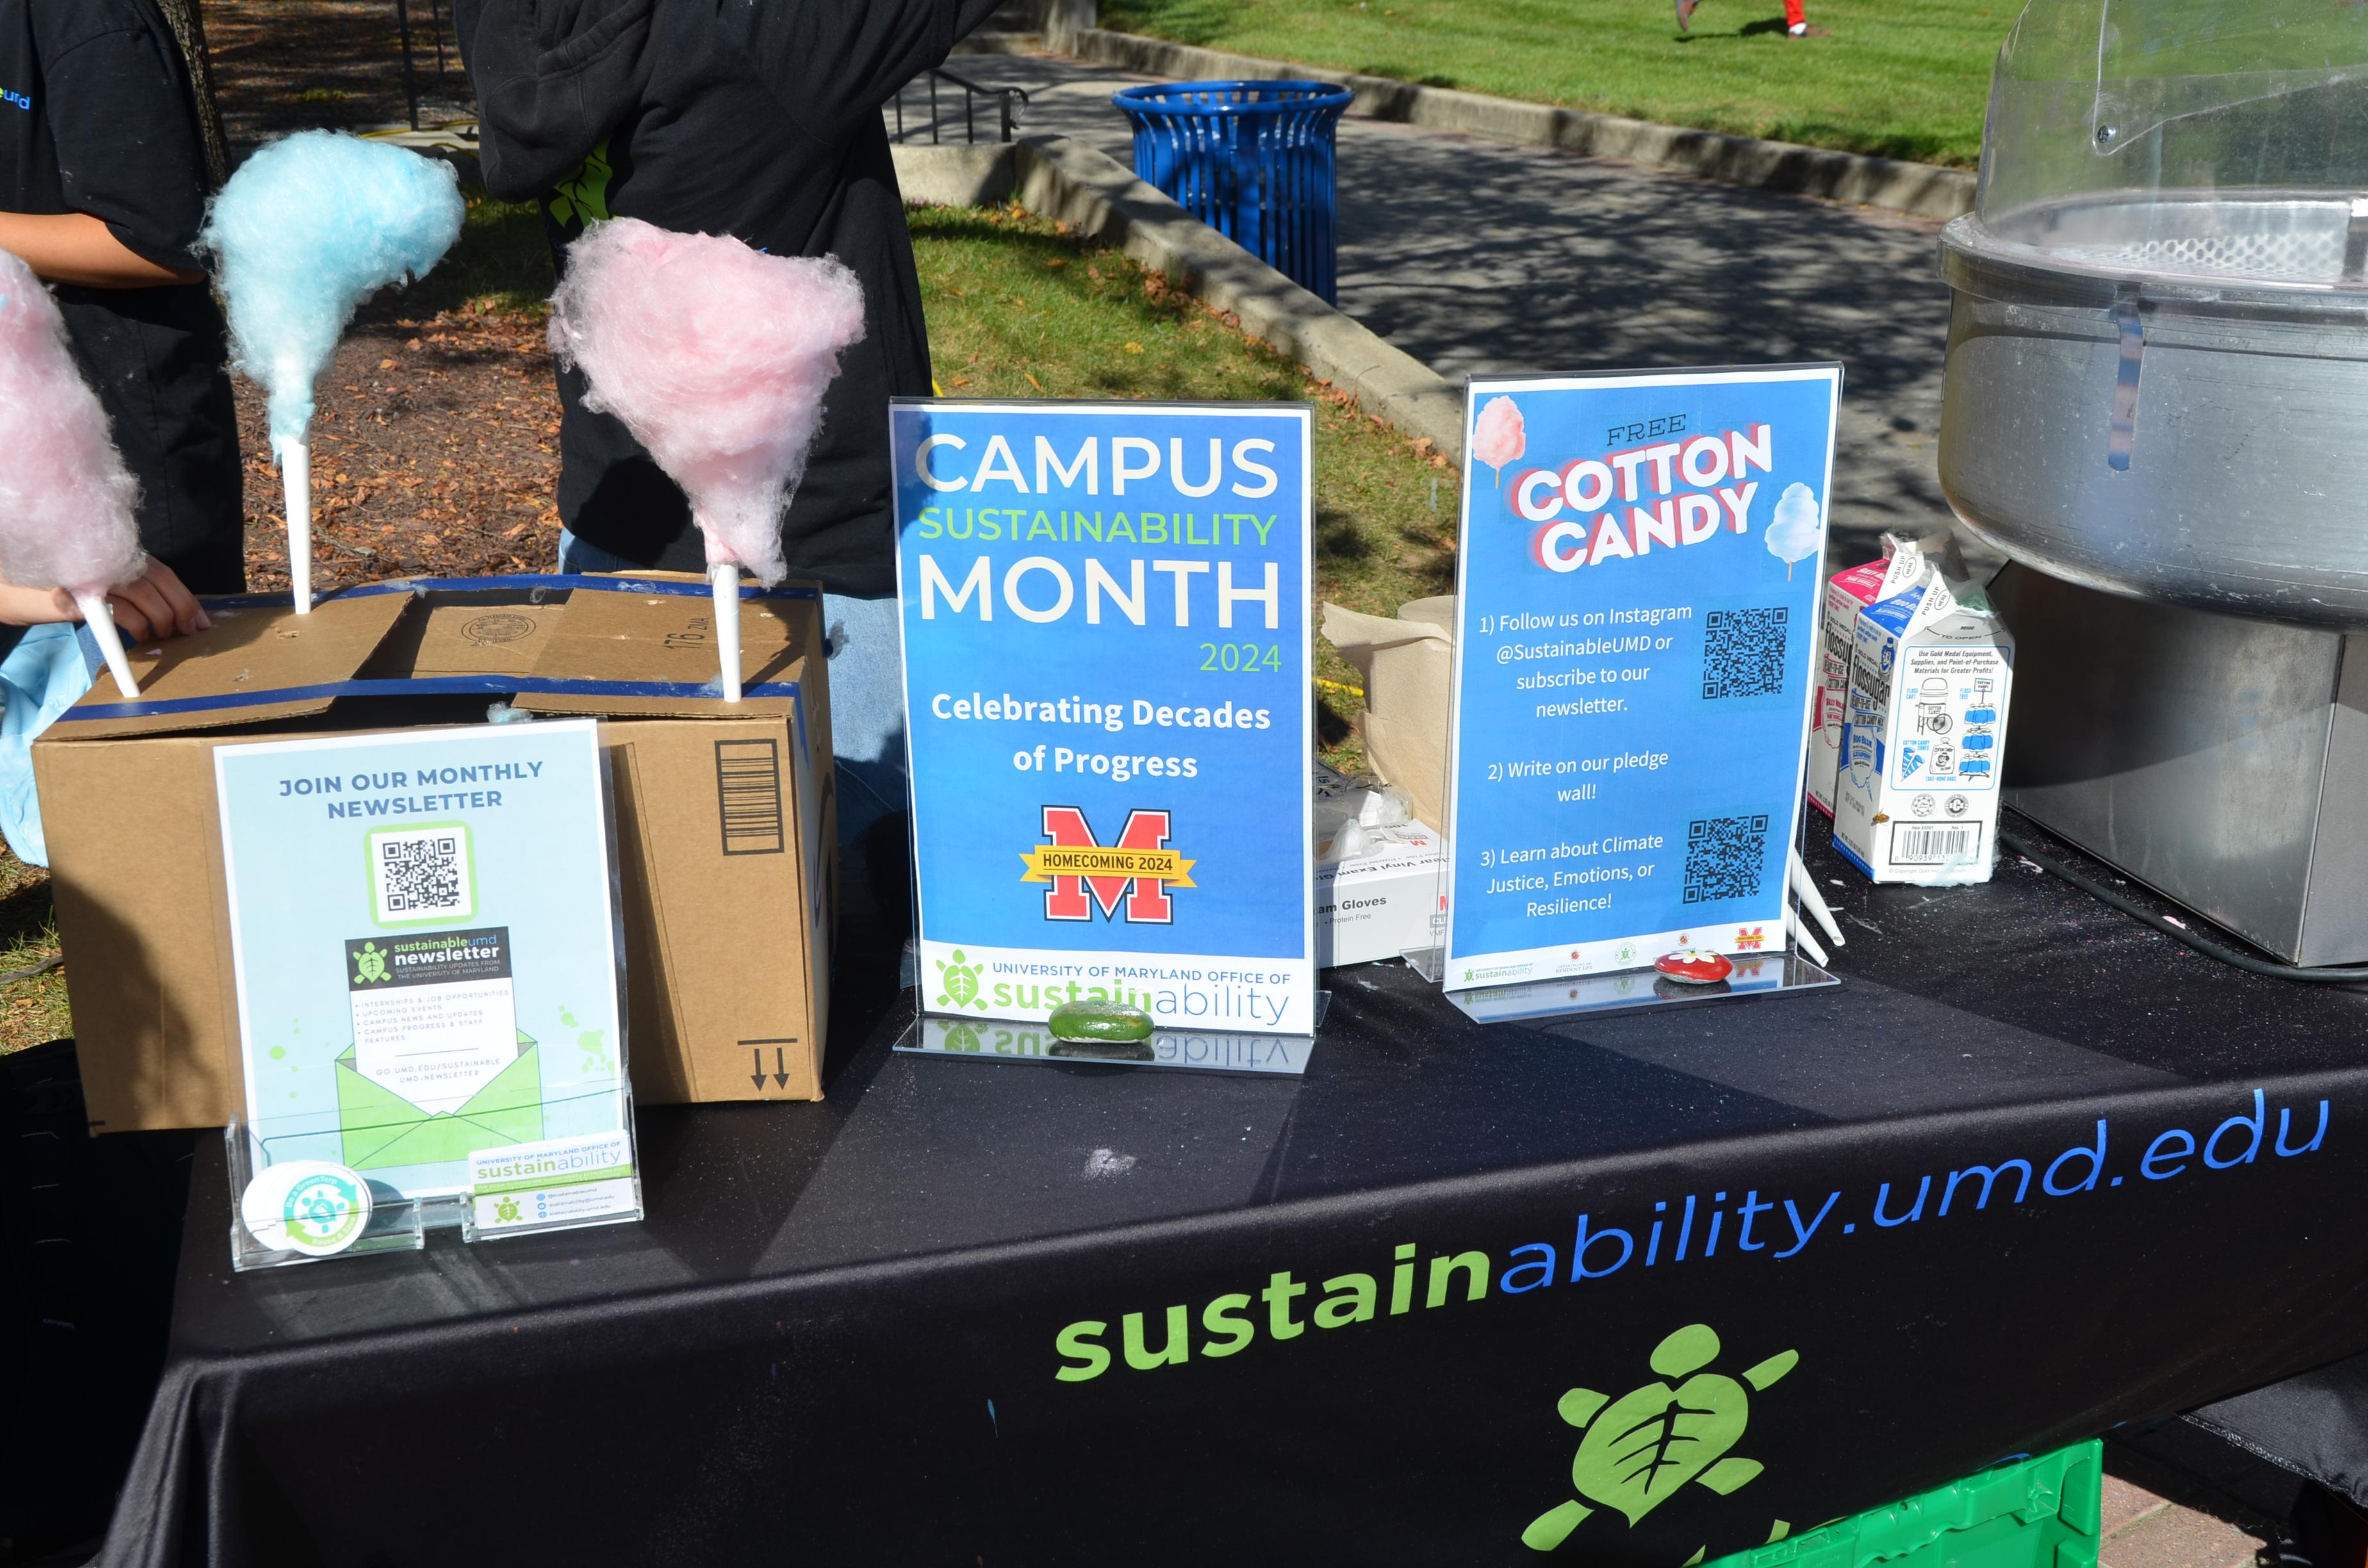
[1101,0,2020,166]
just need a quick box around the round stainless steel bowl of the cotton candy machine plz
[1939,192,2368,630]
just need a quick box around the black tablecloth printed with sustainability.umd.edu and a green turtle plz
[104,831,2368,1568]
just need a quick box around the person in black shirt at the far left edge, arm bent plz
[0,0,246,601]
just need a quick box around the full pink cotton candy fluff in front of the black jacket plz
[552,218,864,585]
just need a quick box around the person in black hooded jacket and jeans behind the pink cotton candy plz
[452,0,997,862]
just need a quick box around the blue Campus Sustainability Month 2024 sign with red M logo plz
[892,403,1314,1033]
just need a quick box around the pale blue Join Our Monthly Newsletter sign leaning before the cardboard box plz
[213,720,639,1229]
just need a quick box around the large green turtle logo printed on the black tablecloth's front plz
[1520,1324,1800,1551]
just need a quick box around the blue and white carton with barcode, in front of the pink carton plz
[1833,554,2015,886]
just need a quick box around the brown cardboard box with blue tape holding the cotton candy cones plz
[33,573,836,1132]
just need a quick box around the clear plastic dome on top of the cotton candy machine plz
[1975,0,2368,291]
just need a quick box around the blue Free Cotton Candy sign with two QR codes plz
[1445,364,1842,990]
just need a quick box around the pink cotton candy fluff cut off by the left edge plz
[0,251,147,594]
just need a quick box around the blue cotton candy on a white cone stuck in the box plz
[204,130,466,616]
